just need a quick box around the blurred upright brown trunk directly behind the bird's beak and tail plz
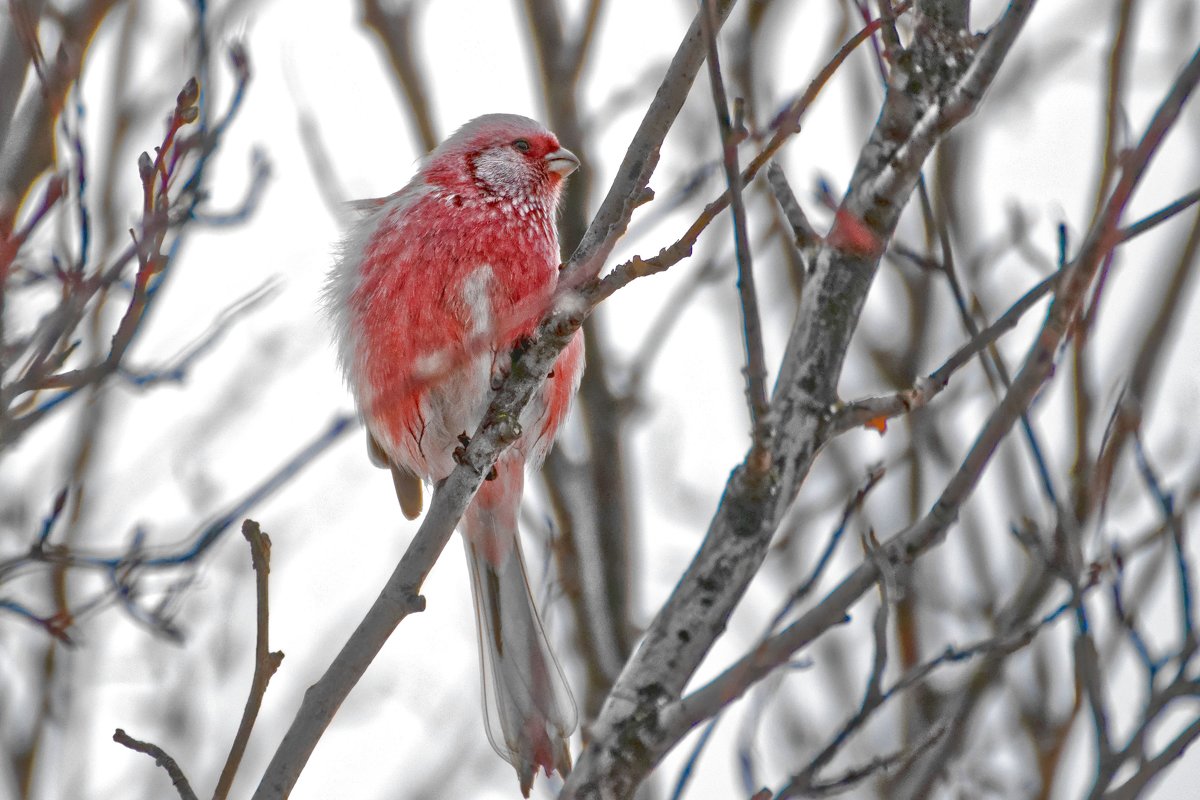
[524,0,637,724]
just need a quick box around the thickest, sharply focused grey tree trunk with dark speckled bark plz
[563,2,1032,800]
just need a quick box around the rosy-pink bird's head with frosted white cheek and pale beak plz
[422,114,580,205]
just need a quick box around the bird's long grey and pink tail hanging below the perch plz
[462,458,576,798]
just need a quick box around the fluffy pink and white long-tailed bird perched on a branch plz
[325,114,583,796]
